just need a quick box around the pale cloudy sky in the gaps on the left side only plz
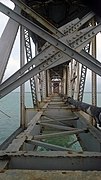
[0,0,35,91]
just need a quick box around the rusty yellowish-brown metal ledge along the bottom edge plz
[0,170,101,180]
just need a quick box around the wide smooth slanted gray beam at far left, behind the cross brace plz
[0,7,20,83]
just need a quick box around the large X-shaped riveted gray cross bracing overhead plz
[0,5,101,97]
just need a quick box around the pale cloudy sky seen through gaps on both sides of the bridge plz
[0,0,101,92]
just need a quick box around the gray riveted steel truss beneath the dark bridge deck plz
[0,0,101,175]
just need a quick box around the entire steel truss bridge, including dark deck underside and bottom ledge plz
[0,0,101,179]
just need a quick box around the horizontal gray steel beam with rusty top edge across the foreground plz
[0,151,101,171]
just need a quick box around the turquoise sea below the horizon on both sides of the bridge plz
[0,92,101,144]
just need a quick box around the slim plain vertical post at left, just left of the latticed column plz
[20,26,25,128]
